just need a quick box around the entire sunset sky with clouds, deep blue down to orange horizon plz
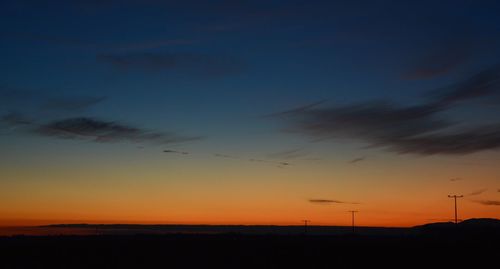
[0,0,500,226]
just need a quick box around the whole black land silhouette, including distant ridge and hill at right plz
[0,219,500,268]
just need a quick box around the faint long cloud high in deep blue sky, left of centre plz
[97,53,244,76]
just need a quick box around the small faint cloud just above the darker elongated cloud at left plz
[41,96,106,111]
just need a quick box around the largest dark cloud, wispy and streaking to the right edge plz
[273,67,500,155]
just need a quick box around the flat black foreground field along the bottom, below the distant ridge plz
[0,231,500,268]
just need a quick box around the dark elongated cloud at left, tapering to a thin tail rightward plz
[34,117,200,144]
